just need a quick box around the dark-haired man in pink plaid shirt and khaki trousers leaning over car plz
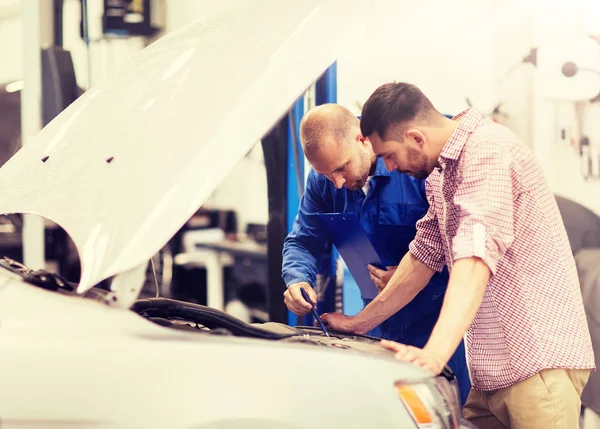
[323,83,594,429]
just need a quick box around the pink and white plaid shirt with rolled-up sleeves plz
[410,109,594,390]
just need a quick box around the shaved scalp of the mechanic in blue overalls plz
[300,104,360,155]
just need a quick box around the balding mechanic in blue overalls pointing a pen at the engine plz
[282,104,471,403]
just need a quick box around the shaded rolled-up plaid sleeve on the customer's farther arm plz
[408,201,445,272]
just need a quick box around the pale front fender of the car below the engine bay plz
[0,269,429,428]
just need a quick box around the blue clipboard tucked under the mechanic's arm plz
[317,213,387,299]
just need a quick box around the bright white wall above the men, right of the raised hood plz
[338,0,600,214]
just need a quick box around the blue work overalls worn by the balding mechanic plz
[282,158,471,404]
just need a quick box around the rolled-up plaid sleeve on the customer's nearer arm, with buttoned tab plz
[452,142,514,275]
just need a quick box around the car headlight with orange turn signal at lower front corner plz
[395,377,461,429]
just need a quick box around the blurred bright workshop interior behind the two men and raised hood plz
[0,0,600,424]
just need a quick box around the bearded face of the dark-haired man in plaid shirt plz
[369,128,433,179]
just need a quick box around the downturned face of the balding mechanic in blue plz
[306,136,374,191]
